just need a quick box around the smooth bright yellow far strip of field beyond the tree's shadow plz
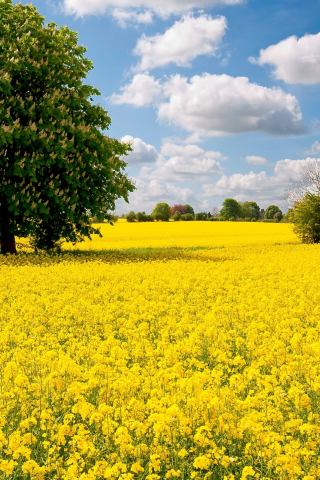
[70,220,298,250]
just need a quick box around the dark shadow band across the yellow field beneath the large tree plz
[0,247,235,266]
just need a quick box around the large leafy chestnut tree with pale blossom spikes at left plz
[0,0,134,253]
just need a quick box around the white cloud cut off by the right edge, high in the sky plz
[249,33,320,85]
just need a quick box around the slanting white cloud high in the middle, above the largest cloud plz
[133,14,227,71]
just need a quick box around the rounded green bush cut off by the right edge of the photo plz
[291,193,320,243]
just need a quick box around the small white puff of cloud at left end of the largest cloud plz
[110,73,162,107]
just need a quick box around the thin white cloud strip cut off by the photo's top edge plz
[63,0,245,17]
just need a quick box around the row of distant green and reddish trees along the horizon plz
[125,198,288,223]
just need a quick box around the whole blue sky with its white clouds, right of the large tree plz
[16,0,320,213]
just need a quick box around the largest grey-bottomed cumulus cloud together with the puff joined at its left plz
[111,73,307,137]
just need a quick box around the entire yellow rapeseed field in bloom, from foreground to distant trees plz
[0,222,320,480]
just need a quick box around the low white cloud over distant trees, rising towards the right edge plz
[203,158,320,199]
